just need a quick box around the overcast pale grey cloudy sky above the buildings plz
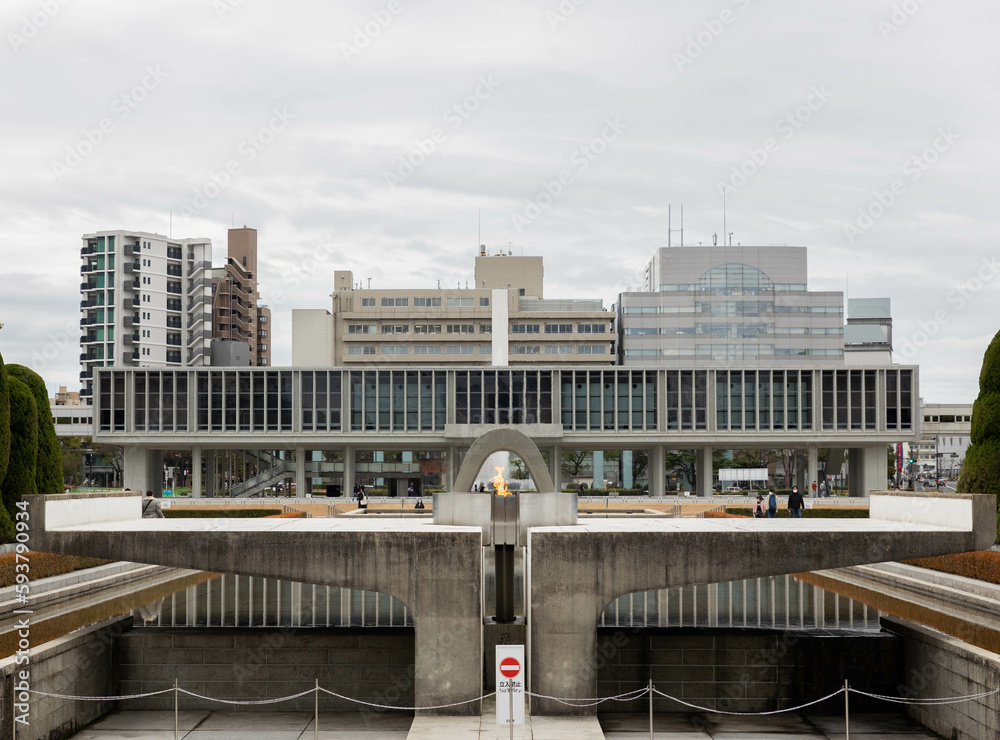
[0,0,1000,402]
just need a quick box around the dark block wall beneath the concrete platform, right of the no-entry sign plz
[594,629,903,714]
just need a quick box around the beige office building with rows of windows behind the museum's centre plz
[292,250,615,367]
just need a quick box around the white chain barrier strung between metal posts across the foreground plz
[28,686,1000,717]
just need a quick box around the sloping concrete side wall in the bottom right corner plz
[882,617,1000,740]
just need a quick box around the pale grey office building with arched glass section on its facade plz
[617,246,844,367]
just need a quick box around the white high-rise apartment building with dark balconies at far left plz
[80,230,212,403]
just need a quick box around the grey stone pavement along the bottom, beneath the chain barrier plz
[73,708,940,740]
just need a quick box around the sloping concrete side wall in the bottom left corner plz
[0,617,132,740]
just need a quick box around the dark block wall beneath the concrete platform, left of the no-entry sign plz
[118,627,414,712]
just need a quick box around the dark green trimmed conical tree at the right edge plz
[957,332,1000,526]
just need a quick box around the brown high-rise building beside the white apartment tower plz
[212,226,271,366]
